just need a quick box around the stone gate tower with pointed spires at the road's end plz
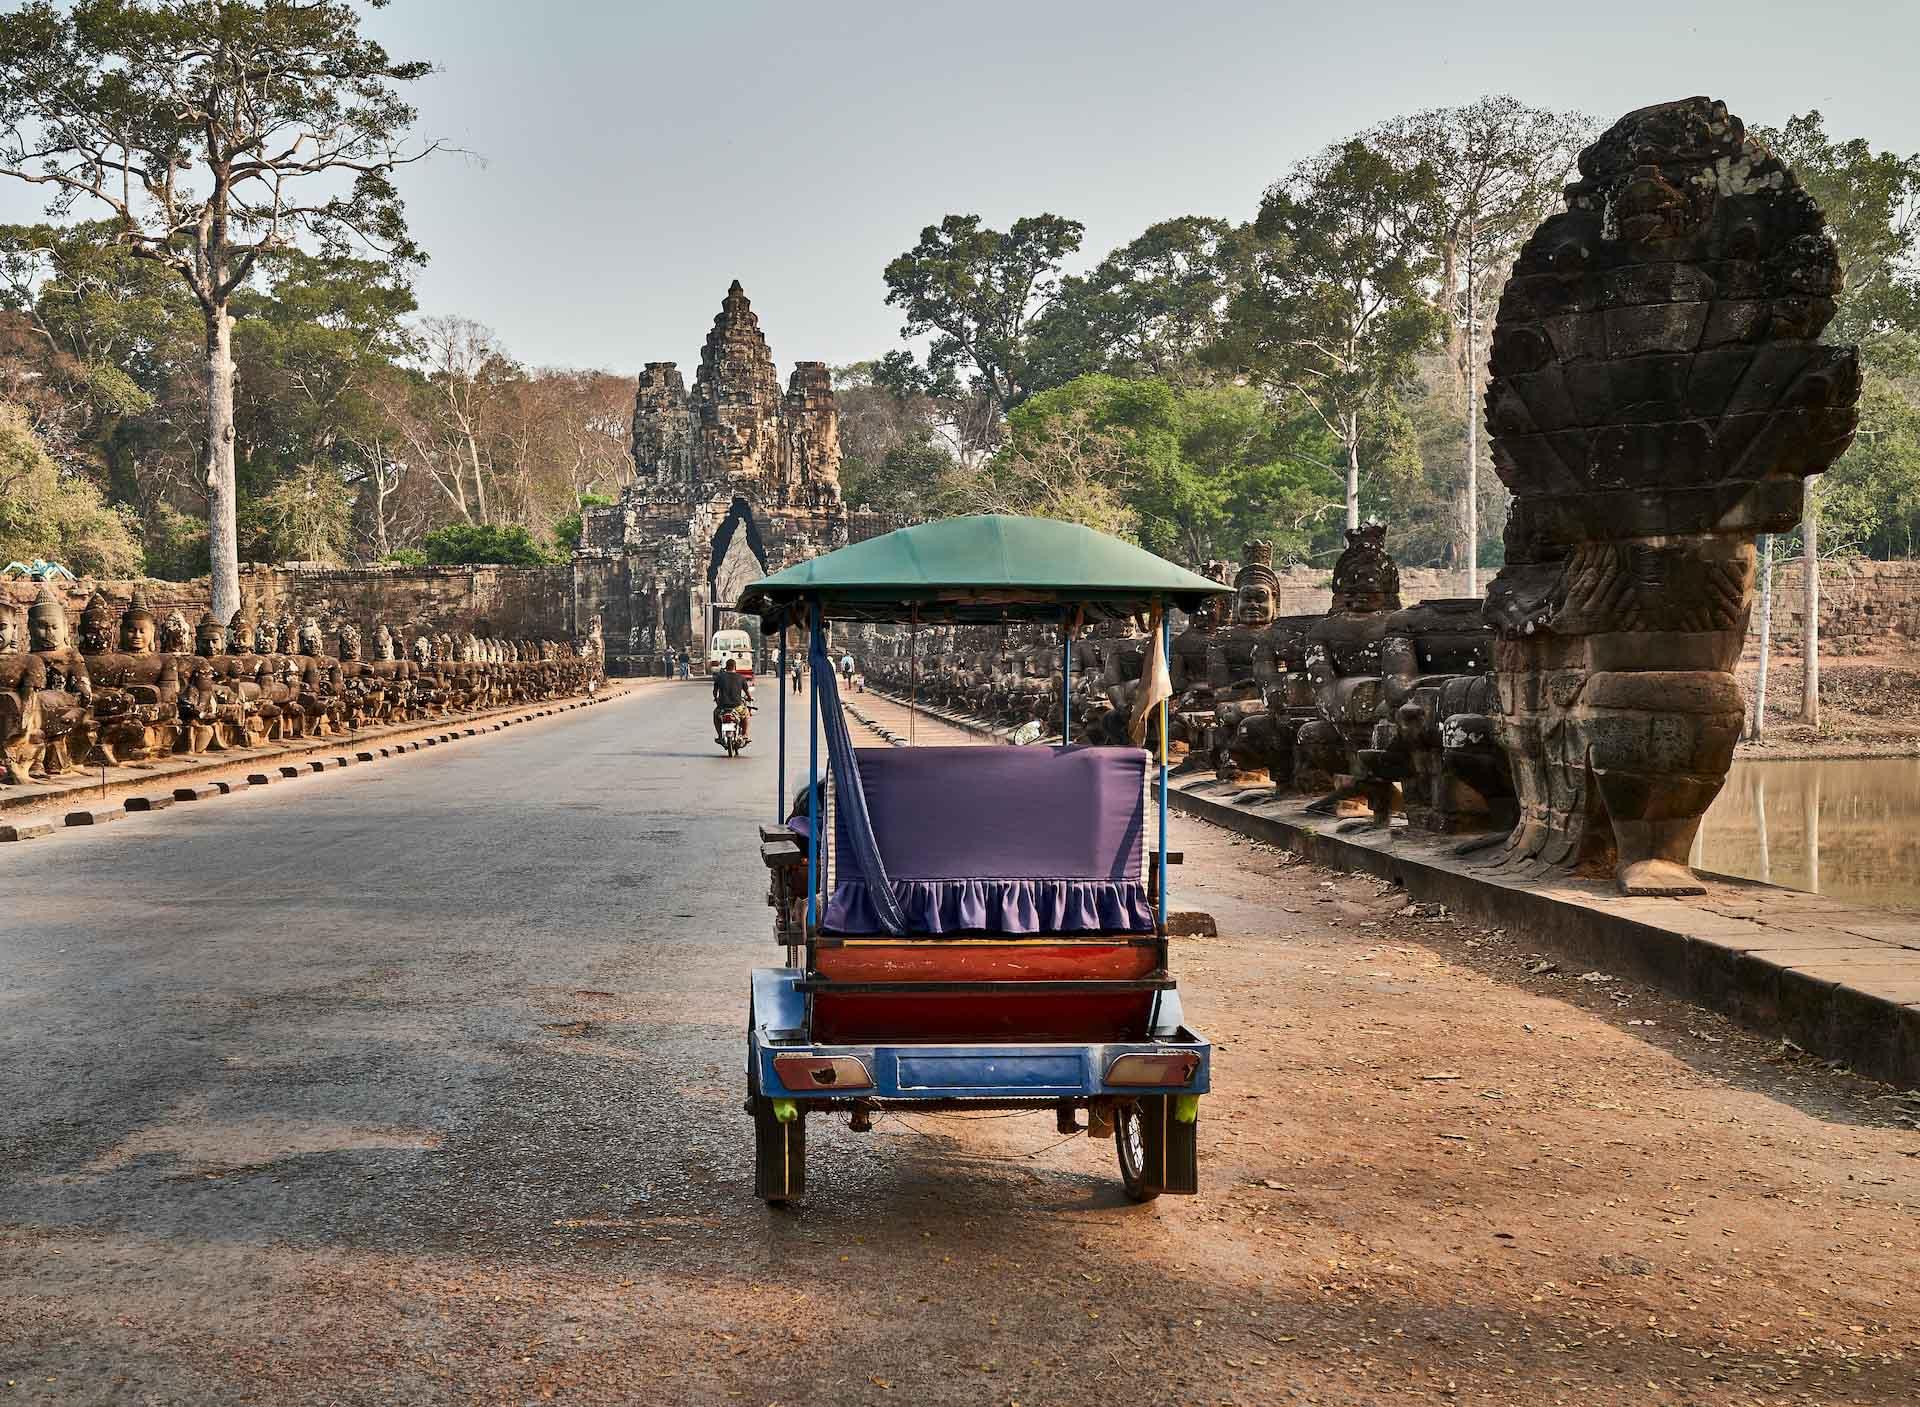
[574,280,872,672]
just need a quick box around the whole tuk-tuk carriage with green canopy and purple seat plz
[737,514,1229,1204]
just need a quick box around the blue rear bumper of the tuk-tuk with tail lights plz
[747,967,1213,1108]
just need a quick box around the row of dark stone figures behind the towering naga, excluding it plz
[868,526,1515,831]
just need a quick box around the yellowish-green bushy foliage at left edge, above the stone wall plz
[0,405,140,576]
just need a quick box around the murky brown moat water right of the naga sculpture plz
[1693,758,1920,912]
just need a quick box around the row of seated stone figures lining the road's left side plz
[0,585,605,785]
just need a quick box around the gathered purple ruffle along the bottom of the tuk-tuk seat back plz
[822,879,1154,935]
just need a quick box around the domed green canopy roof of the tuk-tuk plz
[735,514,1233,624]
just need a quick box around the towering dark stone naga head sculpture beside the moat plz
[1486,98,1860,894]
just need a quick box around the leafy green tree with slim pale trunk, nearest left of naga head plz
[1213,138,1442,528]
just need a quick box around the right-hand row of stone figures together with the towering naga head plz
[867,98,1860,894]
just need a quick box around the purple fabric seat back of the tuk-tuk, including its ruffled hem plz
[826,747,1154,935]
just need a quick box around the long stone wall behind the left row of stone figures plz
[0,564,588,639]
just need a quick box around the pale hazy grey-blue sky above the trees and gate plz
[0,0,1920,370]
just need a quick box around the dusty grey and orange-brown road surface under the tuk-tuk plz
[0,683,1920,1405]
